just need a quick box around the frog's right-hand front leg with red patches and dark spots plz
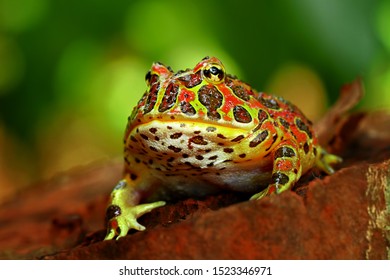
[251,141,302,200]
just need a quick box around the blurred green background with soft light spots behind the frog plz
[0,0,390,202]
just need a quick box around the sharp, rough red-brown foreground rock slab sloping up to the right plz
[45,160,390,259]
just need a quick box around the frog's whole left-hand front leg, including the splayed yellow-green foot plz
[105,175,165,240]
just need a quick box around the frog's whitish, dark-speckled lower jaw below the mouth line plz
[126,121,274,174]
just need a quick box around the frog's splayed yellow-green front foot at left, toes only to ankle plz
[104,201,165,240]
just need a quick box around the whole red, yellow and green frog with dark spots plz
[105,57,341,239]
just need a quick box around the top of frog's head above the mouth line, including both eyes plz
[131,57,258,125]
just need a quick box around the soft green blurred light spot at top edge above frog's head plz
[125,1,212,59]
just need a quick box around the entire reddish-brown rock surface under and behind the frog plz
[0,110,390,259]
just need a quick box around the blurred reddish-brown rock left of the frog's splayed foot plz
[0,161,122,259]
